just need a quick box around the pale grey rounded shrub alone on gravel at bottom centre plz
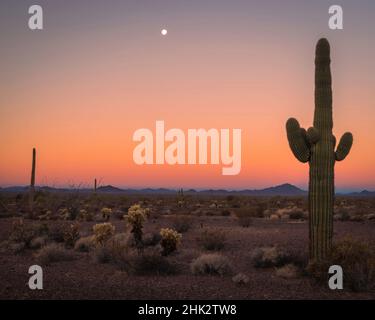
[190,253,232,276]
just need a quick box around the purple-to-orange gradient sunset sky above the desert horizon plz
[0,0,375,190]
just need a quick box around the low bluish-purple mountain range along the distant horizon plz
[0,183,375,197]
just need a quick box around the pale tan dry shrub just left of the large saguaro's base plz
[251,247,289,268]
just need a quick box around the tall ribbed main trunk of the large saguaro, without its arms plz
[309,41,335,260]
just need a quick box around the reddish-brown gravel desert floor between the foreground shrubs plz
[0,208,375,299]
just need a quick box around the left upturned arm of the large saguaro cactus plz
[286,118,310,163]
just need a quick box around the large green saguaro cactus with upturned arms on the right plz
[286,39,353,261]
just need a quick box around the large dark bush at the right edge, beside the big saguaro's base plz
[307,238,375,291]
